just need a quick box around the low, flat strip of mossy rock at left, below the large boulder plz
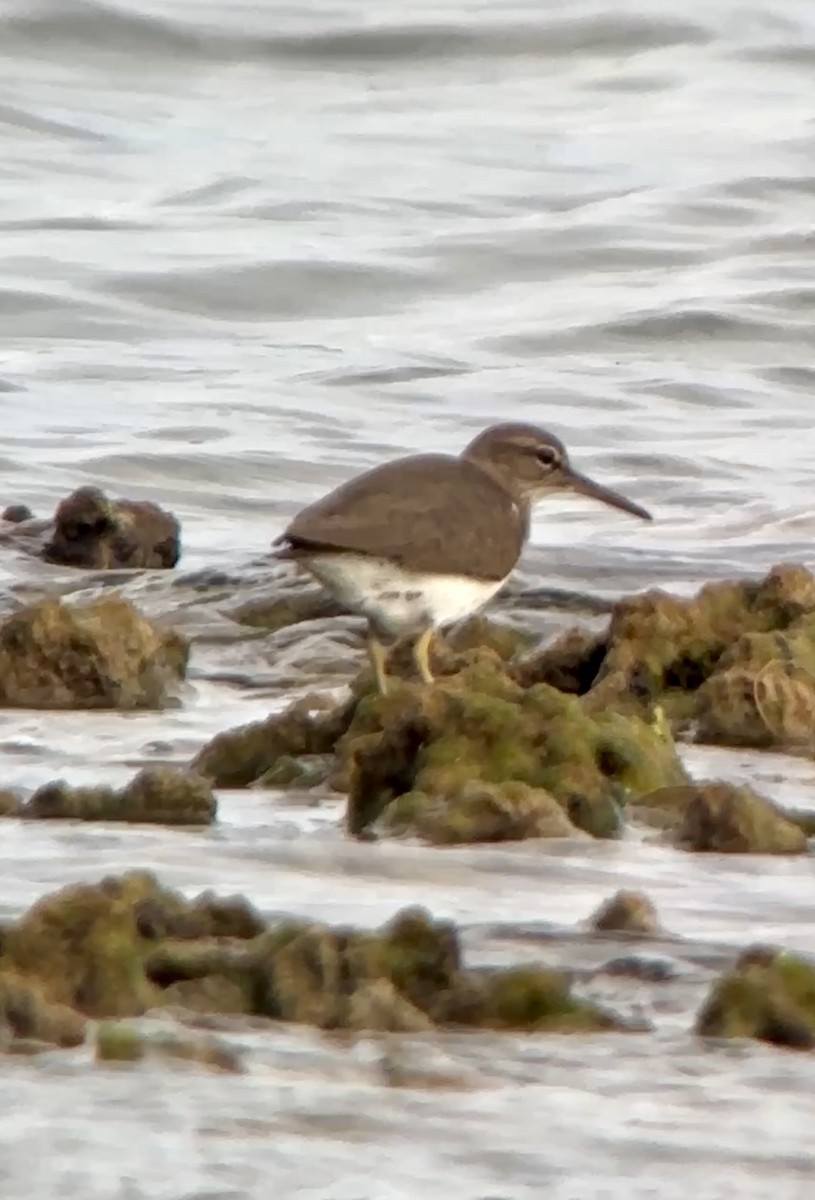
[17,767,217,826]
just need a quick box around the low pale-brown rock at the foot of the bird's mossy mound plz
[384,780,586,846]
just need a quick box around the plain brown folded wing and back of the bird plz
[277,455,527,580]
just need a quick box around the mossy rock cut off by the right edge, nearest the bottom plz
[696,947,815,1050]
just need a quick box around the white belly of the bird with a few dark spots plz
[304,554,504,637]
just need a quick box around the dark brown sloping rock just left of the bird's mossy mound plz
[190,704,353,787]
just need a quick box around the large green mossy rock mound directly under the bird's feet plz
[337,652,687,836]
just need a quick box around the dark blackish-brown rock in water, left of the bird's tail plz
[41,487,181,570]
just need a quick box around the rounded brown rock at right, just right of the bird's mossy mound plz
[676,784,808,854]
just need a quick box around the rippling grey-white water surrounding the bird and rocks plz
[0,0,815,1200]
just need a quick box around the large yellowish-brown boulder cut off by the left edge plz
[0,596,188,709]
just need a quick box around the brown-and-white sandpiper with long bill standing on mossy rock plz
[274,424,651,694]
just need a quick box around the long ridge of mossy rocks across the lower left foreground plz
[0,872,625,1041]
